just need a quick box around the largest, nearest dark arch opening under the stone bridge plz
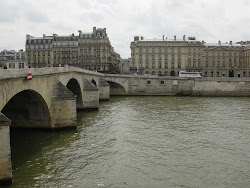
[1,89,51,128]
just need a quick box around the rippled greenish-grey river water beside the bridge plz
[3,97,250,188]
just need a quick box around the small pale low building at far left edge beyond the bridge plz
[0,49,25,69]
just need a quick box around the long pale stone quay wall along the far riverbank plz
[121,77,250,97]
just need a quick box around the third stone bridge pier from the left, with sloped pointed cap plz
[82,79,99,109]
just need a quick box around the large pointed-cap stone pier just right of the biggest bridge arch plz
[49,81,77,128]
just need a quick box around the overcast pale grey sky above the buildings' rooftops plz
[0,0,250,58]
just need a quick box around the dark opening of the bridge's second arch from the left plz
[66,78,83,108]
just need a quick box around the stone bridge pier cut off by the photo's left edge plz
[0,113,12,185]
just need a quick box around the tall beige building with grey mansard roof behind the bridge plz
[26,27,119,73]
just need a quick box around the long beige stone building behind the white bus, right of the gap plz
[130,35,250,77]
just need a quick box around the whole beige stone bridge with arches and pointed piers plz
[0,67,131,184]
